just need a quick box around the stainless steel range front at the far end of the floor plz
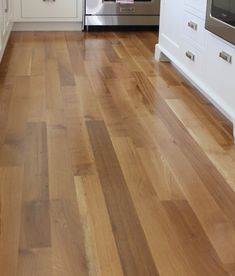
[85,0,160,26]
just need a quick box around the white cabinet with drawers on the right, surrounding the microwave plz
[156,0,235,136]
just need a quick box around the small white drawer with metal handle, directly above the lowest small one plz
[183,11,206,48]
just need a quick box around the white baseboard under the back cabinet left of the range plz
[13,22,82,31]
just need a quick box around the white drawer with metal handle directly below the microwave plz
[206,33,235,108]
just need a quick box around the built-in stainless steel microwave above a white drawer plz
[206,0,235,44]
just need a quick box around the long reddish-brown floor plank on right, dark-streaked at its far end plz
[135,70,235,226]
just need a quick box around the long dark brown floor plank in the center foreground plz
[87,121,158,275]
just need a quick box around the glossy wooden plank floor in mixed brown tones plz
[0,32,235,276]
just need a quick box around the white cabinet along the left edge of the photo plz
[0,0,13,61]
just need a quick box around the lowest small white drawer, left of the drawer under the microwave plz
[181,40,203,78]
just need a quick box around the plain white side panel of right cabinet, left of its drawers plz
[160,0,183,58]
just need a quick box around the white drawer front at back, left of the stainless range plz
[21,0,77,18]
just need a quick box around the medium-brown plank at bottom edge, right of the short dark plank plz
[50,199,89,276]
